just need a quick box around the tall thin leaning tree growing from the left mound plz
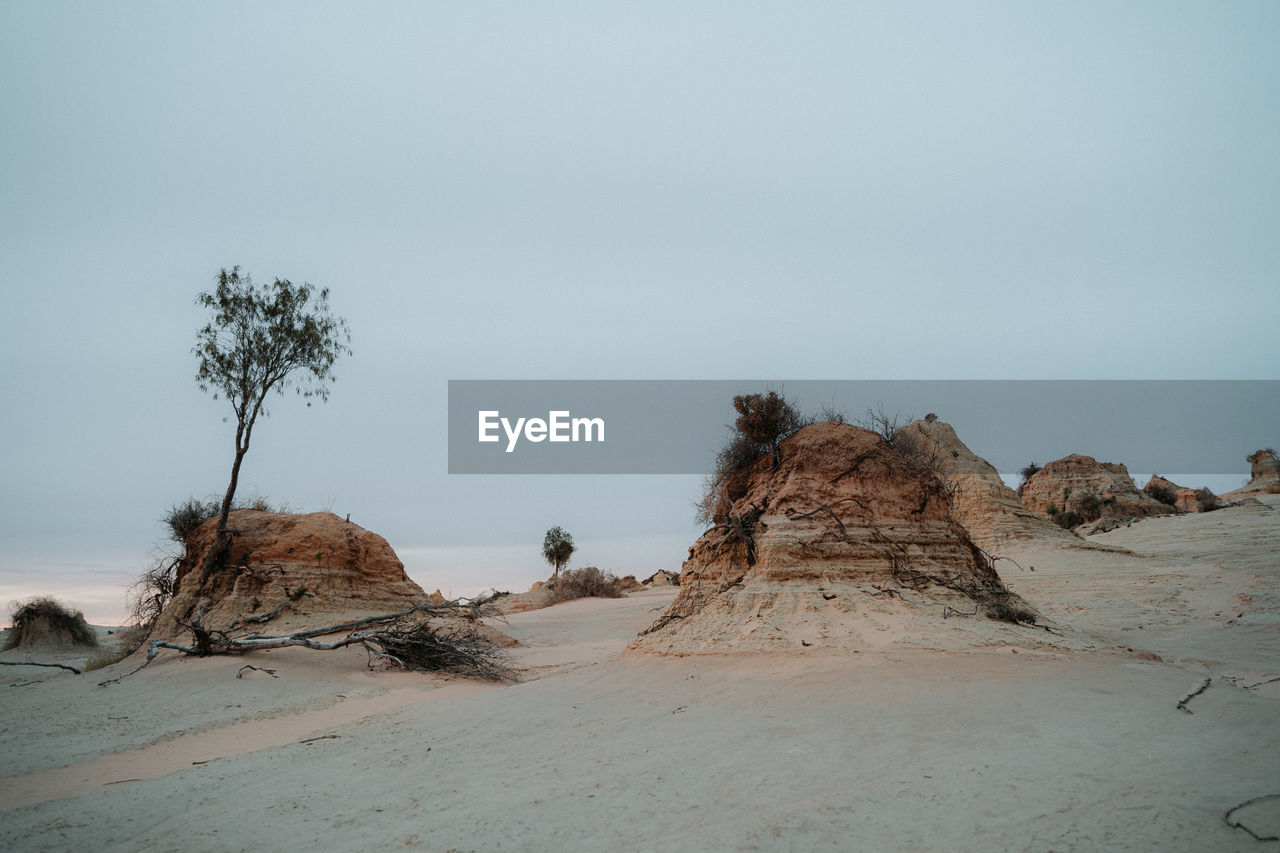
[192,266,351,580]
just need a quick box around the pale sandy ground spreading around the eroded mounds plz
[0,497,1280,850]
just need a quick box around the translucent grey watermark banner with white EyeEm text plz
[448,379,1280,474]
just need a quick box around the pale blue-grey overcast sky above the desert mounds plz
[0,0,1280,621]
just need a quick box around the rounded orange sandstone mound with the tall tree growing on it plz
[155,510,429,637]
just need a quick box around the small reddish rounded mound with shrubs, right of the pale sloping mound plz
[1021,453,1178,526]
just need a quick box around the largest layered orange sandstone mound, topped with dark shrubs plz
[631,423,1034,654]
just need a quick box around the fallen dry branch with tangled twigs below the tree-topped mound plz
[99,599,517,686]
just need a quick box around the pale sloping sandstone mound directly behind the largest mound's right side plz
[895,420,1097,555]
